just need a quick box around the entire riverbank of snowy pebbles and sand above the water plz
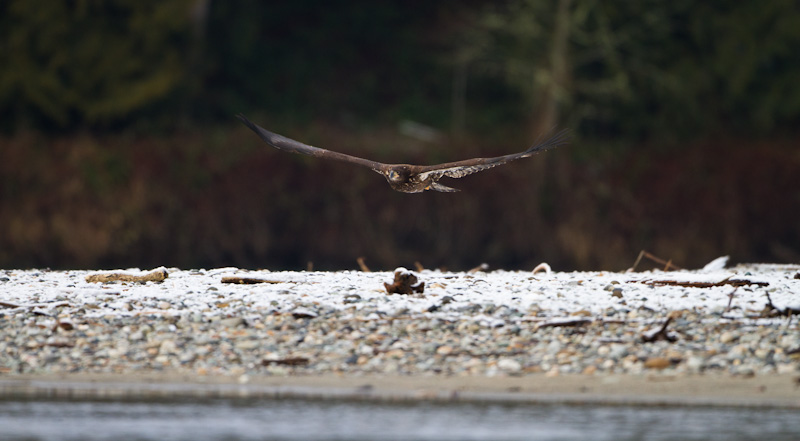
[0,264,800,408]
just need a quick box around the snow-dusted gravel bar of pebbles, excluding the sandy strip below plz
[0,263,800,382]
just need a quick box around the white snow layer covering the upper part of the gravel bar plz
[0,265,800,318]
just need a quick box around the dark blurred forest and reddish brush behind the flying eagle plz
[0,0,800,270]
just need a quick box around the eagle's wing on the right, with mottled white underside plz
[418,129,569,179]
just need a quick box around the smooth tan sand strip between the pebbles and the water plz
[0,372,800,409]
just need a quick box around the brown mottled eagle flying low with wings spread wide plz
[236,114,567,193]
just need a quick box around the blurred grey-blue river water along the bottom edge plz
[0,399,800,441]
